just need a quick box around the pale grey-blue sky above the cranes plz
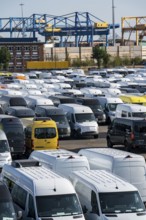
[0,0,146,38]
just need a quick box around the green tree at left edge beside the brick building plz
[0,47,11,70]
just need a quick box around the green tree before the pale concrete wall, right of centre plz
[92,46,109,68]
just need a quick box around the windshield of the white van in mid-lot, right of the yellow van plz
[75,113,95,123]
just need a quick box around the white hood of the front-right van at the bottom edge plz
[103,212,146,220]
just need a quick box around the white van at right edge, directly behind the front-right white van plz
[78,148,146,203]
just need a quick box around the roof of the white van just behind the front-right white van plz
[78,147,145,161]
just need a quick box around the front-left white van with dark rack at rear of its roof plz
[2,160,84,220]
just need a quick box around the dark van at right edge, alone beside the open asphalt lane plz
[106,118,146,150]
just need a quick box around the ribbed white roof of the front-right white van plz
[71,170,137,192]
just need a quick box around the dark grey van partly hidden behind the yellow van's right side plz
[35,106,71,138]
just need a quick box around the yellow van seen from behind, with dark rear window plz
[25,117,59,156]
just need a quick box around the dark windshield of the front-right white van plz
[99,191,145,213]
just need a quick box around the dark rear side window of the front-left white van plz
[11,184,27,210]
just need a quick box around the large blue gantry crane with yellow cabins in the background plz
[0,12,119,47]
